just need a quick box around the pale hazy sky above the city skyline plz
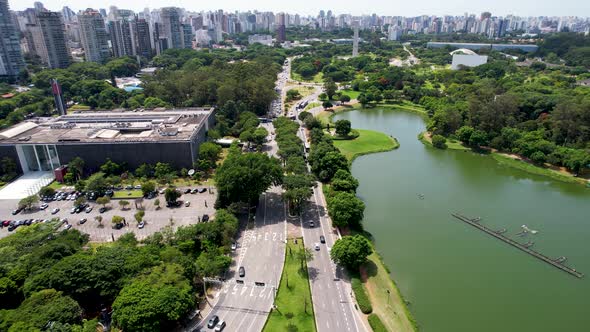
[8,0,590,17]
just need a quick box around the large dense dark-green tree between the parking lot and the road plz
[215,150,283,207]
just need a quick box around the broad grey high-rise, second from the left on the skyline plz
[34,11,70,68]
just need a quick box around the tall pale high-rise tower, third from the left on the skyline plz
[78,8,111,63]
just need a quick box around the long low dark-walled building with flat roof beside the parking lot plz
[0,108,215,174]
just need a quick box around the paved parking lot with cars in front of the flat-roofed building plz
[0,187,216,242]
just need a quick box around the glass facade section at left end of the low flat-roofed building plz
[17,145,60,172]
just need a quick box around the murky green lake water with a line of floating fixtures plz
[334,109,590,332]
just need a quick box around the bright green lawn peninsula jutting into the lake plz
[334,129,399,161]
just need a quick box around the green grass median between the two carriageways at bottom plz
[263,238,316,332]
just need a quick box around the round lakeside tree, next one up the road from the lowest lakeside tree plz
[328,192,365,228]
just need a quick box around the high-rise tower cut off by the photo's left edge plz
[0,0,25,79]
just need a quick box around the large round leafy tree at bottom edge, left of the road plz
[113,263,195,331]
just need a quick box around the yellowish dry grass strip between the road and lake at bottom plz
[364,252,417,332]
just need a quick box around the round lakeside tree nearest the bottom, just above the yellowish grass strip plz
[330,235,373,271]
